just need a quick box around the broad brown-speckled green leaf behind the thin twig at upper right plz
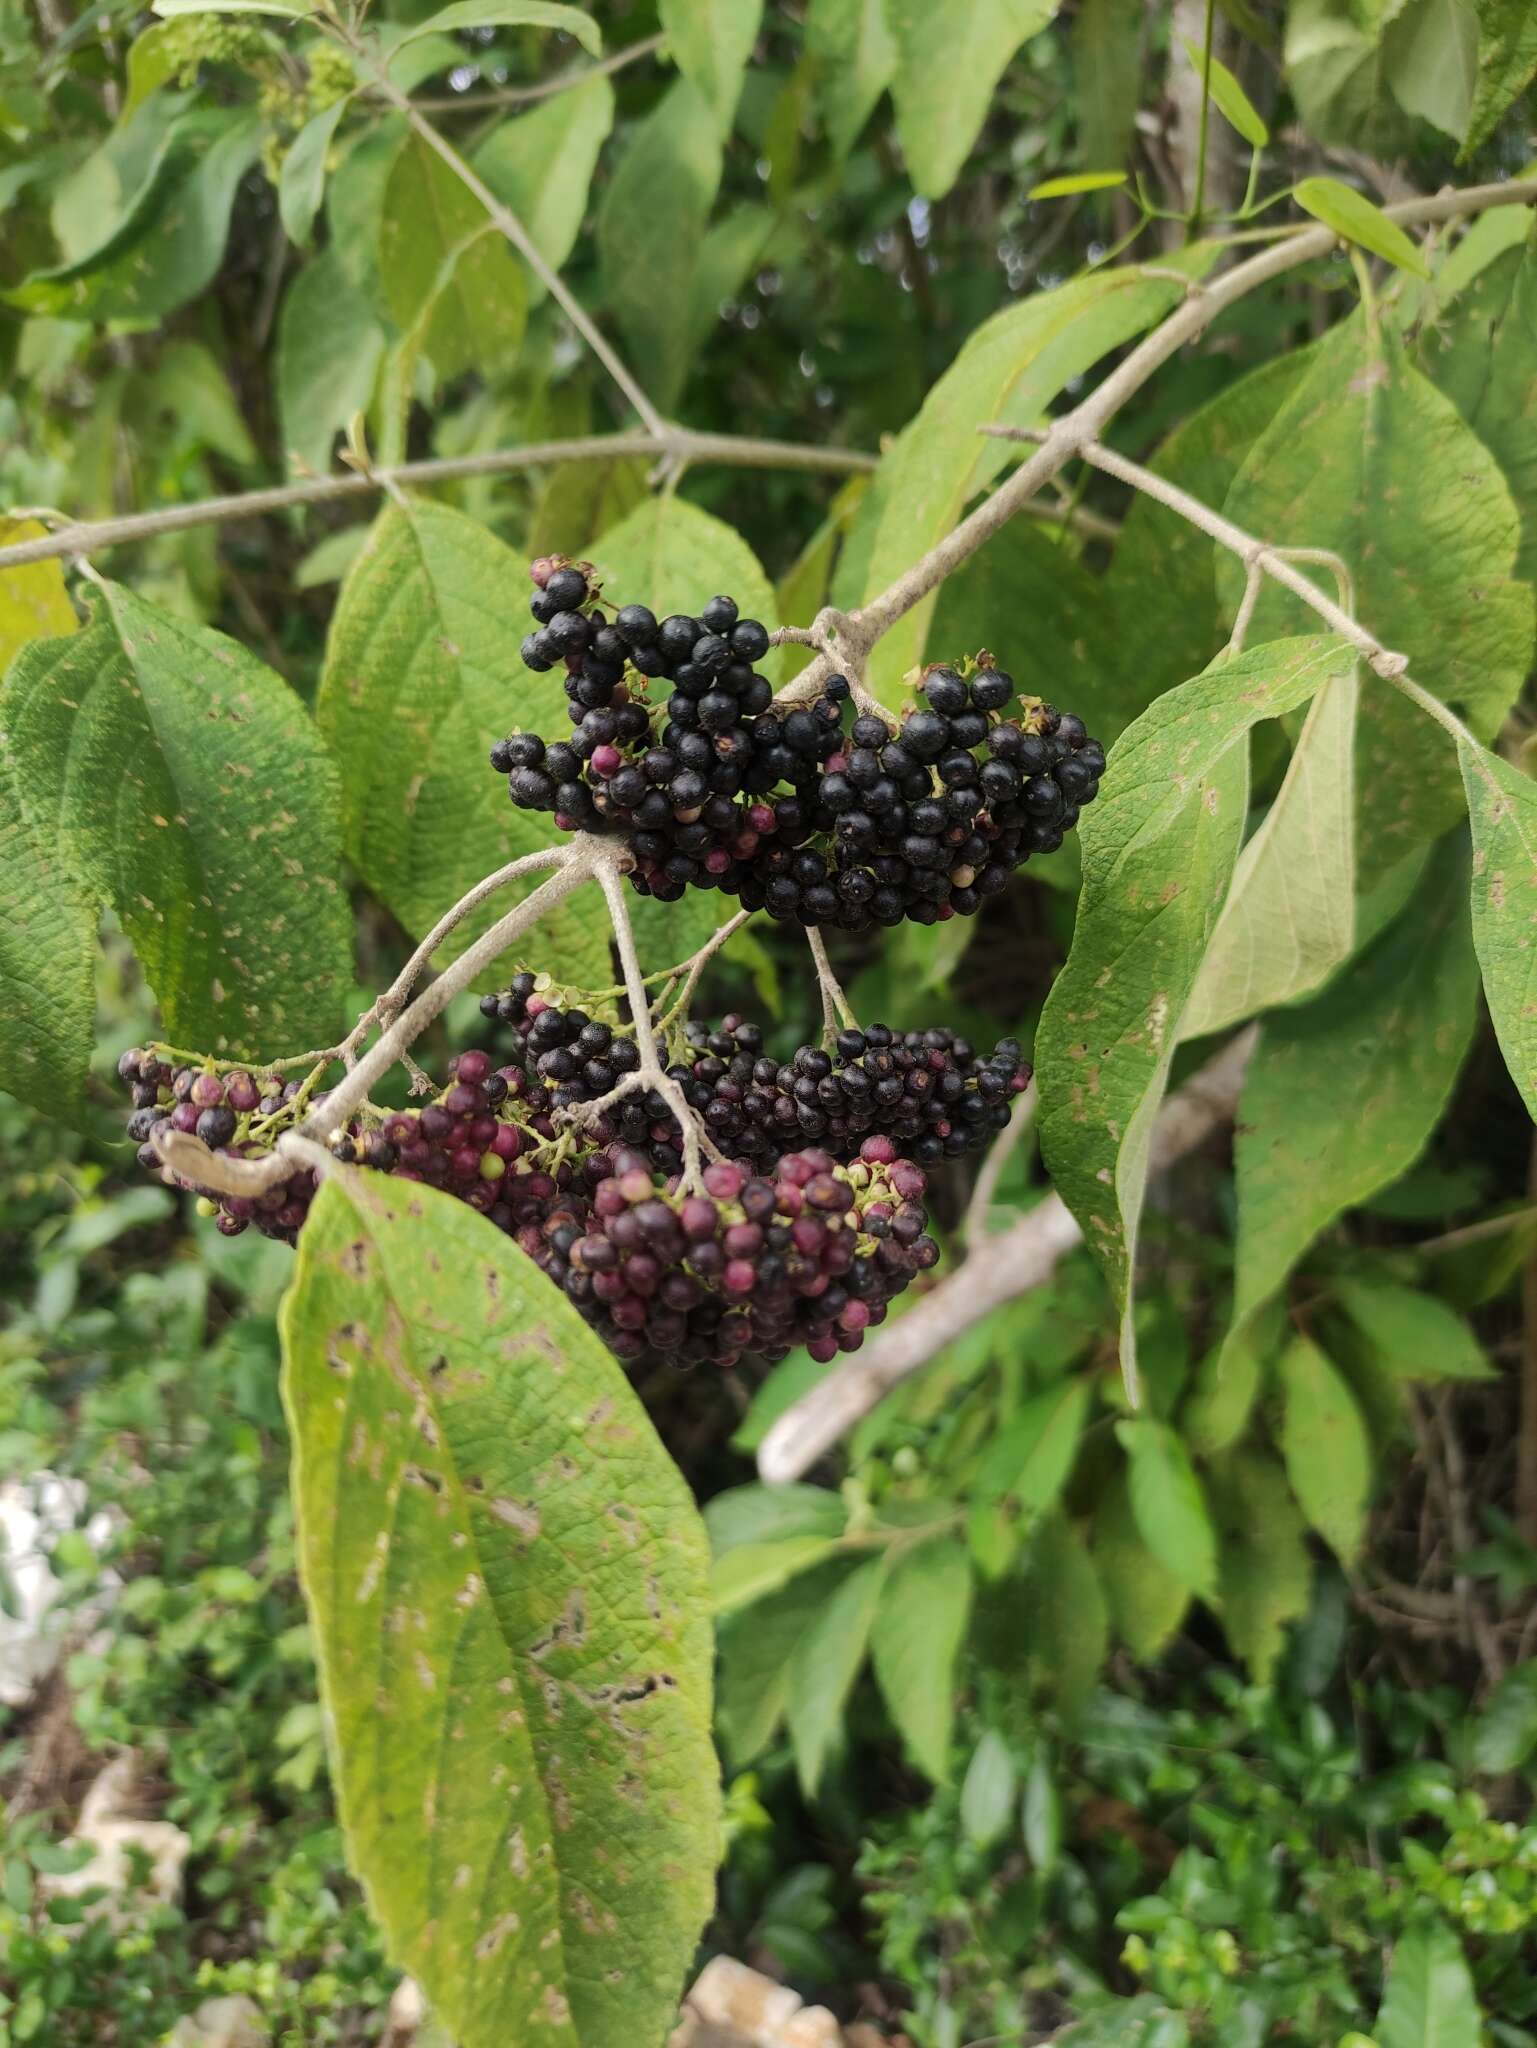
[1217,317,1535,883]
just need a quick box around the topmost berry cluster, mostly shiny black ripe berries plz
[492,559,1105,930]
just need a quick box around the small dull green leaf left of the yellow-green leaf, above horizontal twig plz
[277,250,385,475]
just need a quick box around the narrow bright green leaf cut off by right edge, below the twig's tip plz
[1457,741,1537,1118]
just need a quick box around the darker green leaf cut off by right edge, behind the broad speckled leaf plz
[1420,233,1537,584]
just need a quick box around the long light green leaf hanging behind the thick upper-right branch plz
[863,260,1209,707]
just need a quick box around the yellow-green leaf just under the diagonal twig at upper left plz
[379,135,529,377]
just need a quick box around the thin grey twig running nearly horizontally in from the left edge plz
[0,426,877,569]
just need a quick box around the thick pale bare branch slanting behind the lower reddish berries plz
[758,1026,1258,1485]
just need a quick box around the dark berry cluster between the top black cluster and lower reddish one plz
[480,973,1031,1171]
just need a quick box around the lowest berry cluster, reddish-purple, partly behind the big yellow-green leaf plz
[119,1032,939,1364]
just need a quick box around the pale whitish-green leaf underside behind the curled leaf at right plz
[1180,668,1361,1038]
